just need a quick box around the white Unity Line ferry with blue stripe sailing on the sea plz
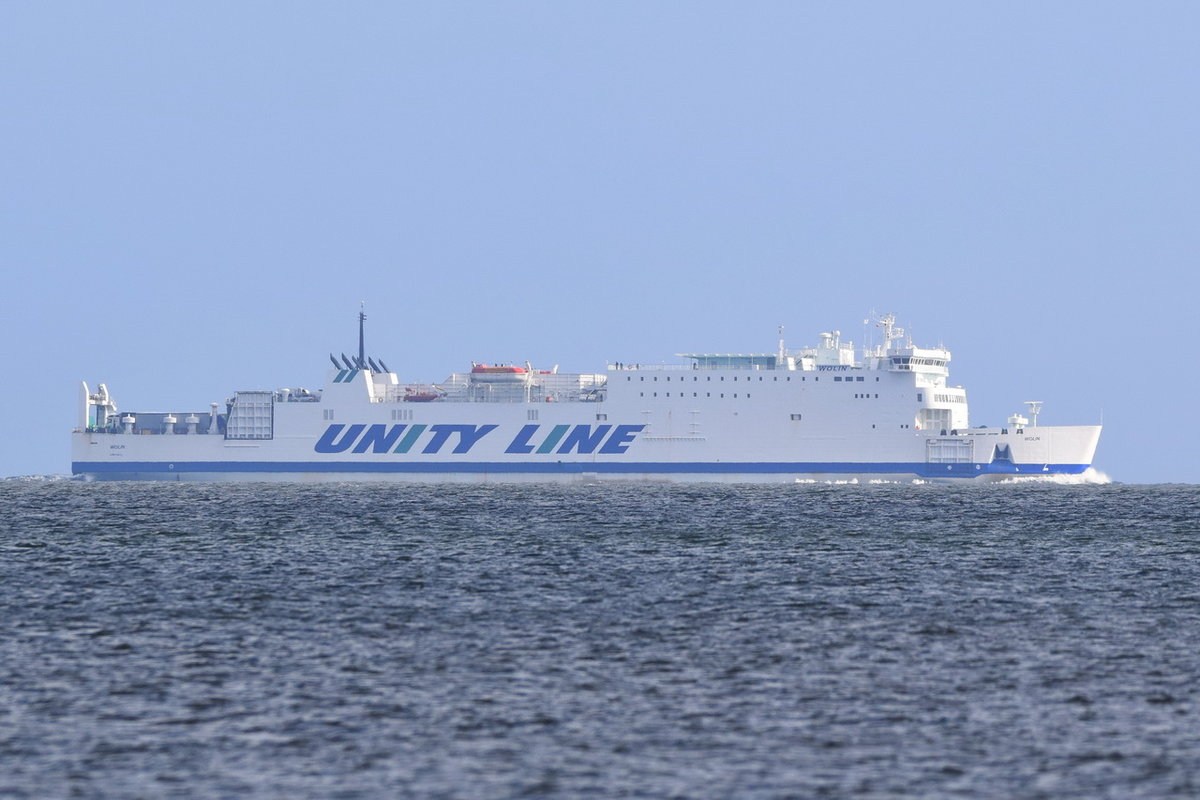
[71,312,1100,483]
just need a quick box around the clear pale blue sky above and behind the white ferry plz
[0,1,1200,482]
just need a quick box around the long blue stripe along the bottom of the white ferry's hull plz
[71,461,1090,477]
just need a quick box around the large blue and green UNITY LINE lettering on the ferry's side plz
[313,423,646,455]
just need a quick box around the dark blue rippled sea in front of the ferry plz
[0,480,1200,800]
